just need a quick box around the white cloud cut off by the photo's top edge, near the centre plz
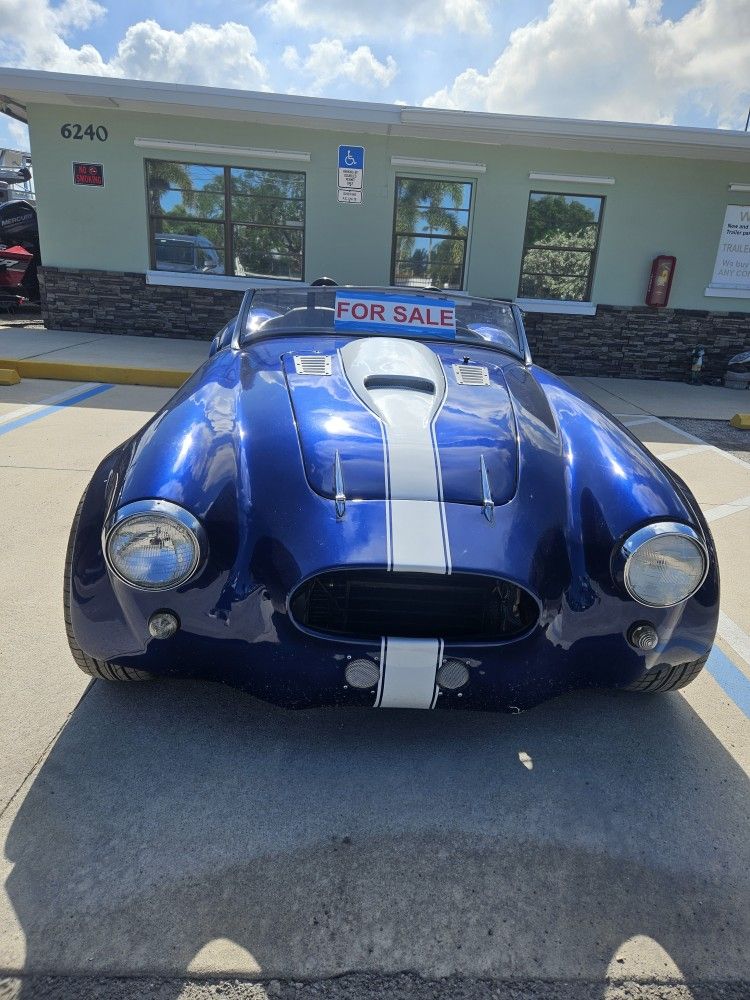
[263,0,491,38]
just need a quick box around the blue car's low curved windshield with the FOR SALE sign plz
[242,286,523,354]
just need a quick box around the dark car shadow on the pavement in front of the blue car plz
[0,680,750,1000]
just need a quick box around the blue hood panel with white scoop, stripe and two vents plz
[283,336,518,505]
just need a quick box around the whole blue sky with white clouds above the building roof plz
[0,0,750,152]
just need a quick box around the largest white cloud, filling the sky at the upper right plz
[424,0,750,128]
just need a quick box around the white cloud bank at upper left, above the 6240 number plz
[0,0,268,89]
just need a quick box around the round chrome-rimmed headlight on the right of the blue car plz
[623,524,708,608]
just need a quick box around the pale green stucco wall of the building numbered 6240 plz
[28,105,750,312]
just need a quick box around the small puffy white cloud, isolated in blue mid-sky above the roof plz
[281,38,398,88]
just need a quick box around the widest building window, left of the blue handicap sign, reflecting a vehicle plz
[146,160,305,281]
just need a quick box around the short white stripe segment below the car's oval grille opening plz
[375,637,443,708]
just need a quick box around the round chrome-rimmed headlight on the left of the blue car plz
[106,501,202,590]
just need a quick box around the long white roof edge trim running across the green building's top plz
[0,68,750,162]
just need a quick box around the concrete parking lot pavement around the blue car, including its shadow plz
[0,379,750,1000]
